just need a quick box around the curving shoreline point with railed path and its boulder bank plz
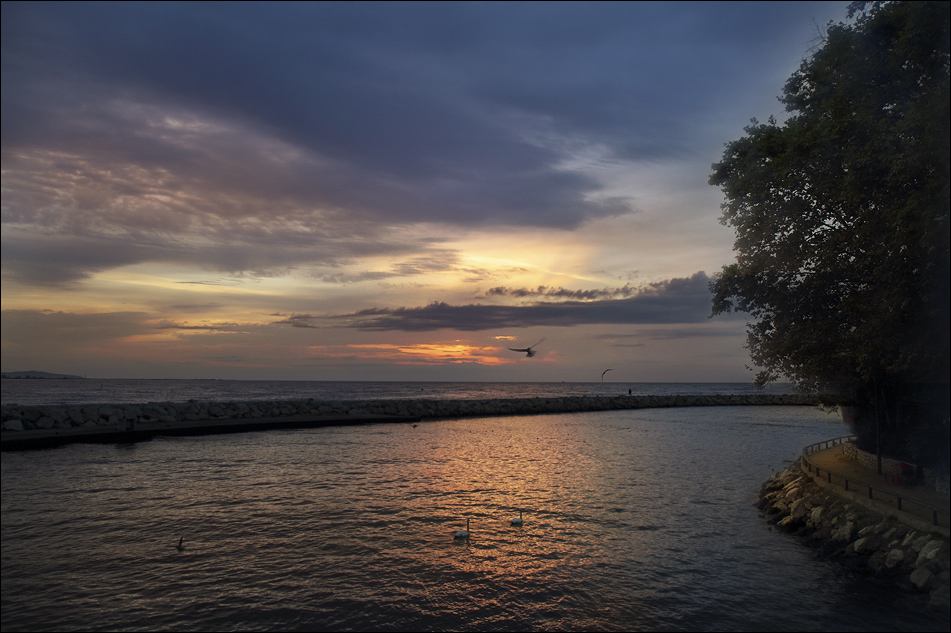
[757,438,951,612]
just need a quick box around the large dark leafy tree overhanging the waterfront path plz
[710,2,951,462]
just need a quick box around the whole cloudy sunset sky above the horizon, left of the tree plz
[0,1,848,382]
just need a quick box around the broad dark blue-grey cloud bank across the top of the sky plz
[3,3,844,207]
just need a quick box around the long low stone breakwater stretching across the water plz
[0,394,819,431]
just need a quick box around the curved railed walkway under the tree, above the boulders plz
[802,438,951,537]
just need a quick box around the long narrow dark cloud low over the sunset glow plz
[275,272,710,332]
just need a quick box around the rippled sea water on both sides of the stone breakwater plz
[0,379,948,631]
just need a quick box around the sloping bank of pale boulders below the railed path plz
[759,462,951,611]
